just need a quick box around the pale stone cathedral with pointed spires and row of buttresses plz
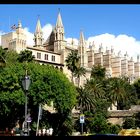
[1,11,140,85]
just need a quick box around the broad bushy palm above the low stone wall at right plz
[106,77,137,109]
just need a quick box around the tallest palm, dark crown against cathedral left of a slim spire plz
[65,50,80,83]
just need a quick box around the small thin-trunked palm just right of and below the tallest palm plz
[74,67,86,87]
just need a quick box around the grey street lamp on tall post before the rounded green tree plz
[22,75,31,134]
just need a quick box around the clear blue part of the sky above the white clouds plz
[0,4,140,40]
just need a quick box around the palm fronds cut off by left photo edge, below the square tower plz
[0,46,6,67]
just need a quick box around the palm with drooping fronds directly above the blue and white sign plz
[77,87,95,113]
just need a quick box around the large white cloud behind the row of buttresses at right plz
[87,33,140,59]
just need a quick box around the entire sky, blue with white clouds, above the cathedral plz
[0,4,140,58]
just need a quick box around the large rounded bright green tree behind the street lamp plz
[0,62,76,135]
